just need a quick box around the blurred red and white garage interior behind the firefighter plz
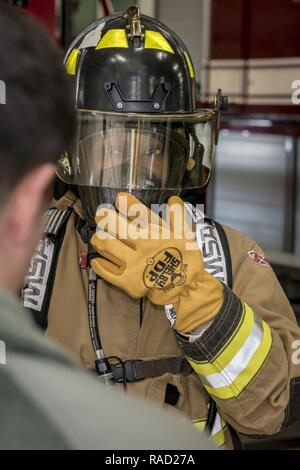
[7,0,300,322]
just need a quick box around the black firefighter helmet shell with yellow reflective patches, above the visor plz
[65,13,196,114]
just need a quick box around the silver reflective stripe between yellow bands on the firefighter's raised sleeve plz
[199,317,263,389]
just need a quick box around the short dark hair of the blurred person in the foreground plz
[0,2,75,199]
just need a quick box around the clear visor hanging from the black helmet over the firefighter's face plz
[57,110,216,192]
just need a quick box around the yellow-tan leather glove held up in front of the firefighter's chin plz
[91,193,223,333]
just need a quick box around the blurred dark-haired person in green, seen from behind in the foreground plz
[0,3,213,449]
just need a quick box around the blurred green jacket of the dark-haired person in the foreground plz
[0,289,210,450]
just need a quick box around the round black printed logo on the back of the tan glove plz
[144,248,187,291]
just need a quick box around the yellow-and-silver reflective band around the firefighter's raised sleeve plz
[189,306,272,399]
